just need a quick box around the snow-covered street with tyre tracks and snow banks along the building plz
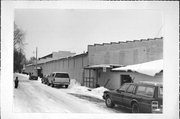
[13,74,128,113]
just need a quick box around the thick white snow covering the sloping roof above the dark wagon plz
[112,59,163,76]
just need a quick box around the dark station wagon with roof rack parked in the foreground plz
[103,82,163,113]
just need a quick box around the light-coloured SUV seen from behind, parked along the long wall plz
[48,72,70,88]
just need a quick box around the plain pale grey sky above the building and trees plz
[15,9,163,59]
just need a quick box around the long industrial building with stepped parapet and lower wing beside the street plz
[26,37,163,89]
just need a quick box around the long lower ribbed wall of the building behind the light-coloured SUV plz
[26,54,88,83]
